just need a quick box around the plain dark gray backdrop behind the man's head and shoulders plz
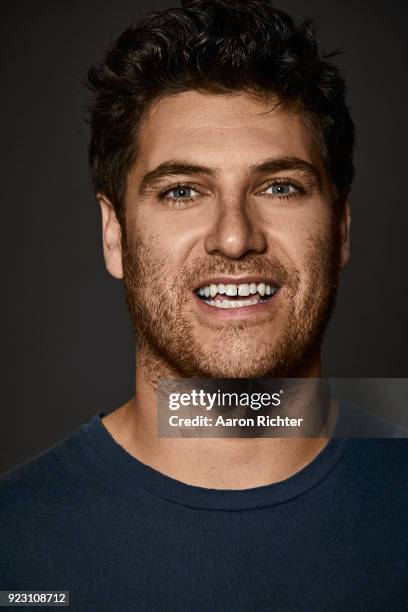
[0,0,408,471]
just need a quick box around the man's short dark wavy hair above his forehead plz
[87,0,354,218]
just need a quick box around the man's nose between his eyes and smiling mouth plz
[204,202,267,259]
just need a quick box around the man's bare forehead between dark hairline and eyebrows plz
[134,91,322,174]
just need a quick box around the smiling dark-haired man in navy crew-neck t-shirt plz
[0,0,408,611]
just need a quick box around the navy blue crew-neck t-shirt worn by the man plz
[0,414,408,612]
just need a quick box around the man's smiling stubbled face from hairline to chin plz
[103,91,348,378]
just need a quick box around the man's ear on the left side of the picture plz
[97,194,123,278]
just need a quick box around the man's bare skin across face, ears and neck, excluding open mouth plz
[99,91,350,489]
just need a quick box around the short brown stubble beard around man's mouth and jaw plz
[122,223,340,382]
